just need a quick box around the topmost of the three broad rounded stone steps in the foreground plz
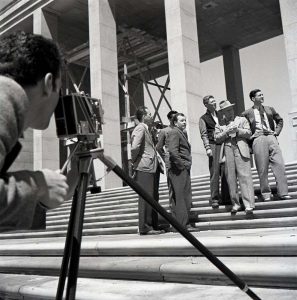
[0,227,297,257]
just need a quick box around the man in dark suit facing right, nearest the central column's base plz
[166,113,192,229]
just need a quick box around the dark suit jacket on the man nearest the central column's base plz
[166,127,192,171]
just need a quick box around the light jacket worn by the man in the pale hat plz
[215,117,252,158]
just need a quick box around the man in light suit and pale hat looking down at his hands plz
[215,100,255,214]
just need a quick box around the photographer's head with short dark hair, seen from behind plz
[0,32,62,129]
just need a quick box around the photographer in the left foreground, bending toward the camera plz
[0,32,75,231]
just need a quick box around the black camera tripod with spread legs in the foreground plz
[56,148,261,300]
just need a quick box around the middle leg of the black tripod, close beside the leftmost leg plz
[66,156,92,300]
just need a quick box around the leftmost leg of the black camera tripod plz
[56,186,78,300]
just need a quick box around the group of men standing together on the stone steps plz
[131,89,291,235]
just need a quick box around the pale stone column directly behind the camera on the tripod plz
[88,0,122,188]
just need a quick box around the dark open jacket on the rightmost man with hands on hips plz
[241,106,284,135]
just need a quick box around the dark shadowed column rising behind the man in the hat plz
[223,46,244,115]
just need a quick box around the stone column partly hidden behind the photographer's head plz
[33,9,60,170]
